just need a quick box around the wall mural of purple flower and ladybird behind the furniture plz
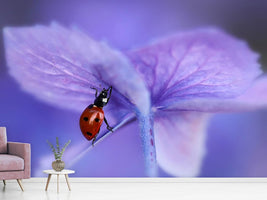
[0,0,267,177]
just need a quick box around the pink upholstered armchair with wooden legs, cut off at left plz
[0,127,31,191]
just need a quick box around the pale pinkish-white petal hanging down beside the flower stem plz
[154,111,209,176]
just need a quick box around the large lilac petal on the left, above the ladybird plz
[4,24,150,115]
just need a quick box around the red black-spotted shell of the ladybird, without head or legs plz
[80,106,104,140]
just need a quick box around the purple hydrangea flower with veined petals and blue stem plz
[4,24,267,176]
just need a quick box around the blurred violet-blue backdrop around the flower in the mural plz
[0,0,267,177]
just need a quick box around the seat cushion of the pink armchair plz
[0,154,24,171]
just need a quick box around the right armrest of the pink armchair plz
[7,142,31,178]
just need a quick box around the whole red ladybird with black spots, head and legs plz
[80,86,113,145]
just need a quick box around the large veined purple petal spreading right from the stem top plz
[128,28,261,107]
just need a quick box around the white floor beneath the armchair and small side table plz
[0,176,267,200]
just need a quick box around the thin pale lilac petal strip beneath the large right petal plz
[164,76,267,112]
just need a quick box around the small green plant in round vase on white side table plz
[47,137,71,171]
